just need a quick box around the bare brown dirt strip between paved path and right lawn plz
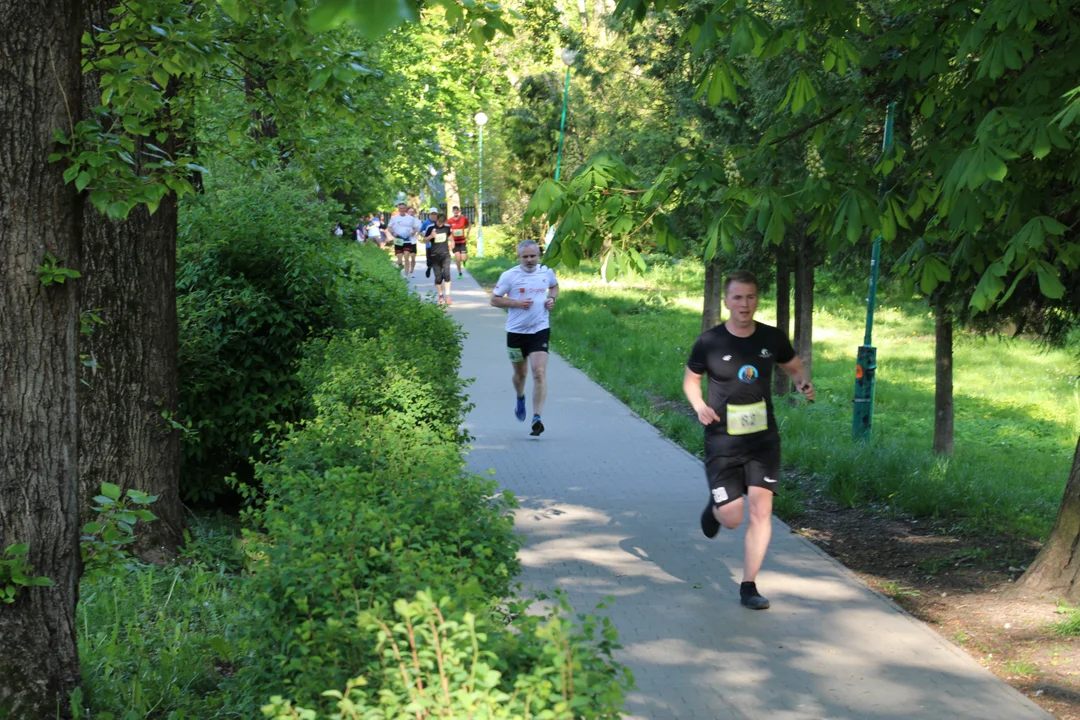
[785,471,1080,720]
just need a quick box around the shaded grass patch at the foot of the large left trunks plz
[76,518,255,720]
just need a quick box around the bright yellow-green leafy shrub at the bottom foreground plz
[262,593,630,720]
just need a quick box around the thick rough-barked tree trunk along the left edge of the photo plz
[0,0,83,719]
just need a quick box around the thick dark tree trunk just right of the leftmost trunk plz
[79,0,184,559]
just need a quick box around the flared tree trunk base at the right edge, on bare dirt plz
[1009,440,1080,601]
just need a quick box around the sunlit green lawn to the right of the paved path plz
[469,228,1080,538]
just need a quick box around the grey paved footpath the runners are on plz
[411,261,1051,720]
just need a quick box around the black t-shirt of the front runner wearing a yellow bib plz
[686,323,795,456]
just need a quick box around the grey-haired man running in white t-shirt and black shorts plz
[491,240,558,436]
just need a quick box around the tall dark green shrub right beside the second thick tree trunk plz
[177,175,353,501]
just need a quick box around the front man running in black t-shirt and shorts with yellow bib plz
[683,270,814,610]
